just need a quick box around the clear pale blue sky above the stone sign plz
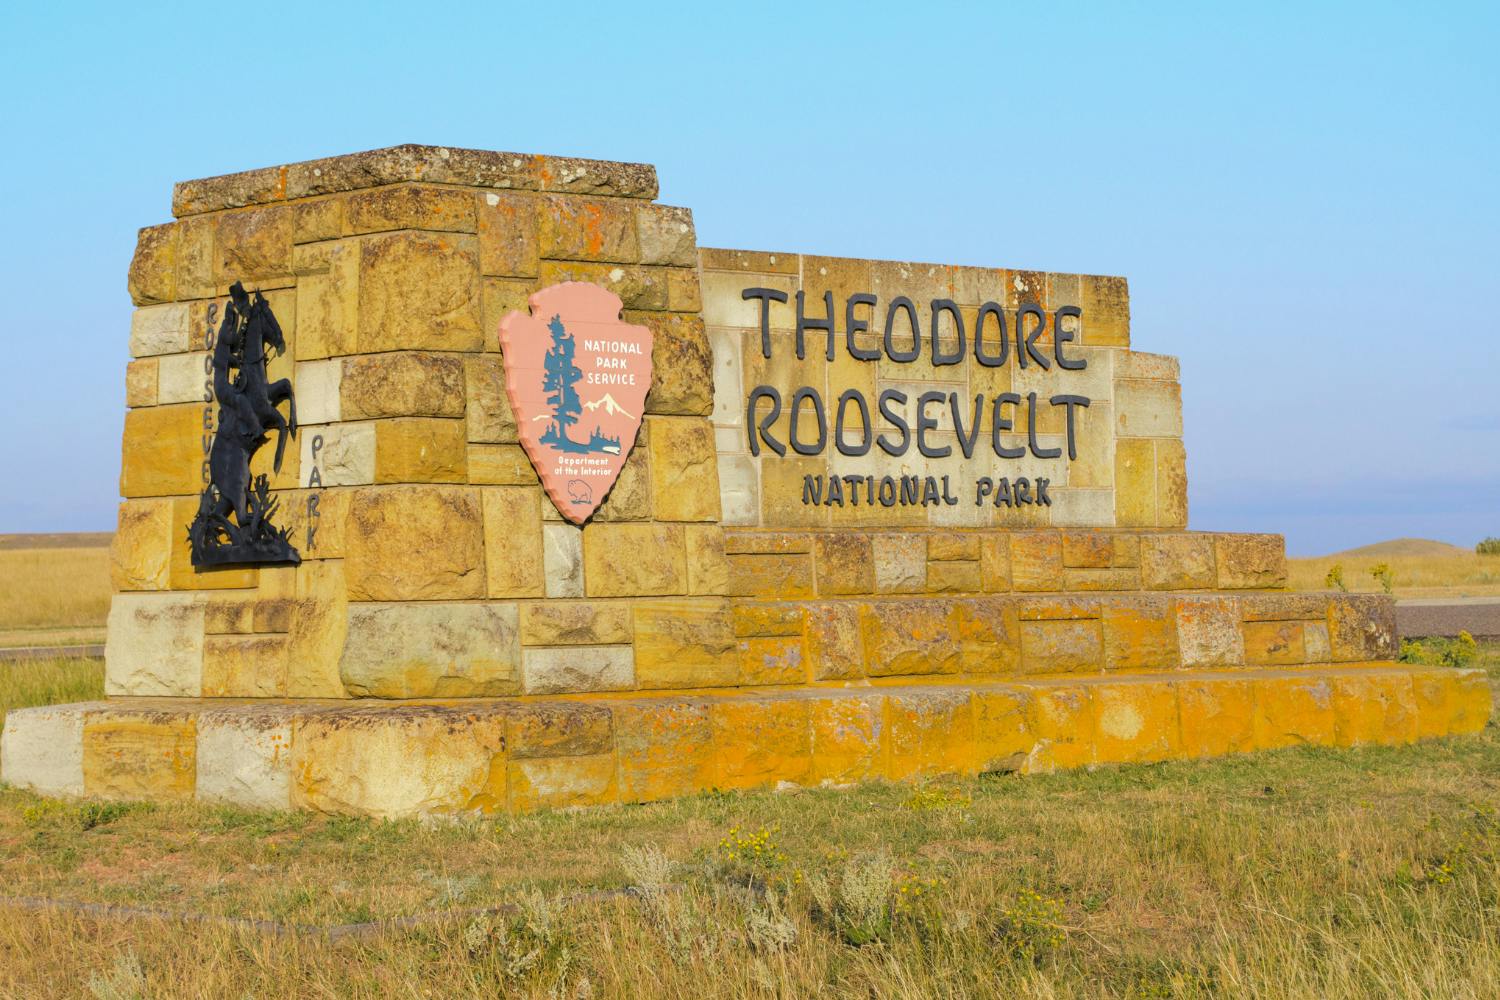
[0,0,1500,555]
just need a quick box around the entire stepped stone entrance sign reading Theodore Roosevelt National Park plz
[0,145,1491,816]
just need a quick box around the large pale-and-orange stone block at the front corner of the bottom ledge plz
[291,705,507,817]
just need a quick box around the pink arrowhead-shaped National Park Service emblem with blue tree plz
[500,282,651,525]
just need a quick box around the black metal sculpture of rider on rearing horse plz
[188,282,302,567]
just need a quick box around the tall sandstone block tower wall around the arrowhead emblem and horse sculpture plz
[107,147,734,697]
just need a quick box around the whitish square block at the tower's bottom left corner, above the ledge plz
[104,594,204,697]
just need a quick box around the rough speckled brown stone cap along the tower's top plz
[173,144,657,219]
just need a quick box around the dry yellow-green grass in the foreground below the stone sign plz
[0,645,1500,1000]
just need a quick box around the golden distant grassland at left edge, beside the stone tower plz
[0,546,110,632]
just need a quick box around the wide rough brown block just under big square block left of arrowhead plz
[339,351,465,420]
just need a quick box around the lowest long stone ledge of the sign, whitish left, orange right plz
[0,663,1491,816]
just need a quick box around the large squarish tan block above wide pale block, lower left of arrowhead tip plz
[344,486,480,601]
